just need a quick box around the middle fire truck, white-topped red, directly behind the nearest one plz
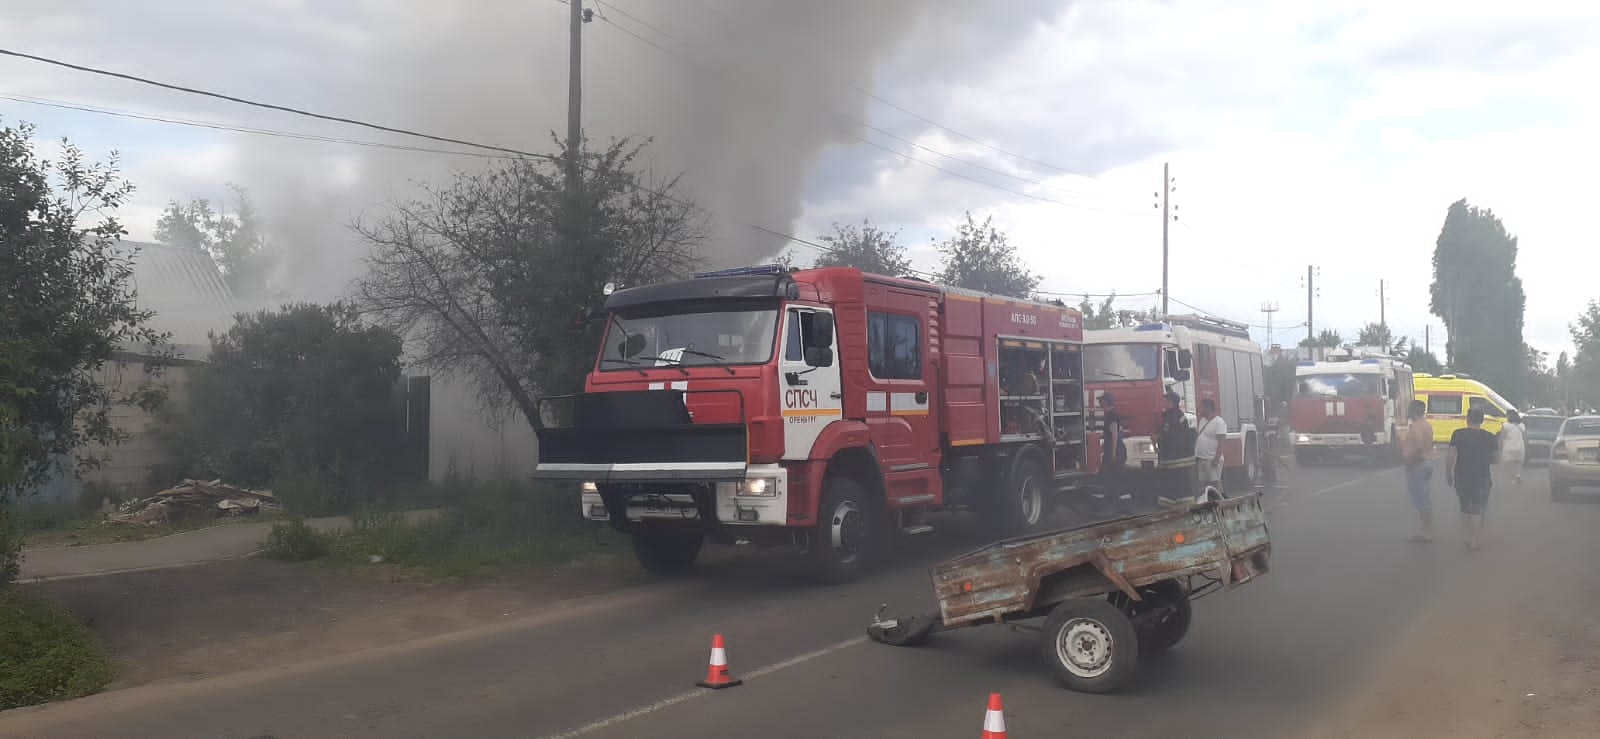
[1083,315,1266,489]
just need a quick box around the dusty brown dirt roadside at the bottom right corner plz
[1307,486,1600,737]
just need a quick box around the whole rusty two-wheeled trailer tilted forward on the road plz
[867,494,1272,693]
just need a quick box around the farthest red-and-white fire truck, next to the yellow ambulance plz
[1290,347,1413,465]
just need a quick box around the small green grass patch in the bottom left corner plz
[0,590,112,710]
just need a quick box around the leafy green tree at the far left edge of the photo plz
[0,119,166,587]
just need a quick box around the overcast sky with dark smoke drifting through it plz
[0,0,1600,363]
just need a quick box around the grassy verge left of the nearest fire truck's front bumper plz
[266,483,613,579]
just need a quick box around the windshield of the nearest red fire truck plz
[600,304,778,371]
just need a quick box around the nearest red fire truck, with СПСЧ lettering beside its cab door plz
[536,266,1098,581]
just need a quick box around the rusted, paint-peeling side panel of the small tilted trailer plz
[931,496,1270,627]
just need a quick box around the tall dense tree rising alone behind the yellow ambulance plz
[1430,200,1526,400]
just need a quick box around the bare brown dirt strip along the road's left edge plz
[22,558,646,689]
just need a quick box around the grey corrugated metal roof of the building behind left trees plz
[120,242,238,358]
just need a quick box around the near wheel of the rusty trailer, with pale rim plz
[1042,598,1139,693]
